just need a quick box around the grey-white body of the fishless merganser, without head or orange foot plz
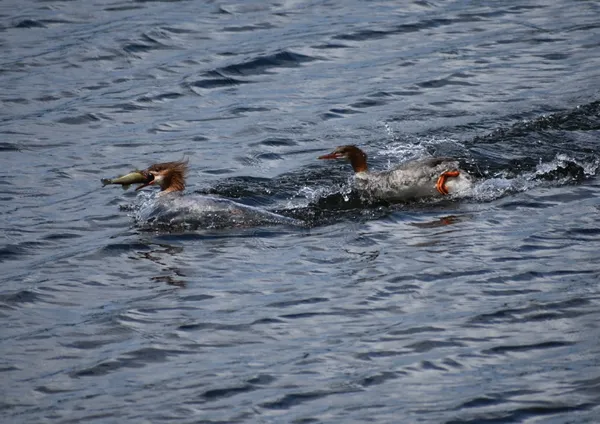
[355,158,473,202]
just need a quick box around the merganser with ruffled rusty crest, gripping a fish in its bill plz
[102,161,303,229]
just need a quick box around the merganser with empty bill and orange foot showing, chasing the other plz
[318,145,472,202]
